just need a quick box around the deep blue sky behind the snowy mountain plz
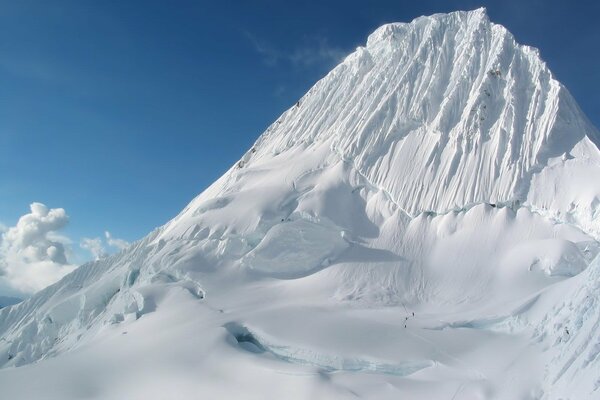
[0,0,600,262]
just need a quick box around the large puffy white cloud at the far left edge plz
[0,203,76,294]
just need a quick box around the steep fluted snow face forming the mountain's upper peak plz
[247,9,597,214]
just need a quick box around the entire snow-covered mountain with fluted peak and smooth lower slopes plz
[0,9,600,399]
